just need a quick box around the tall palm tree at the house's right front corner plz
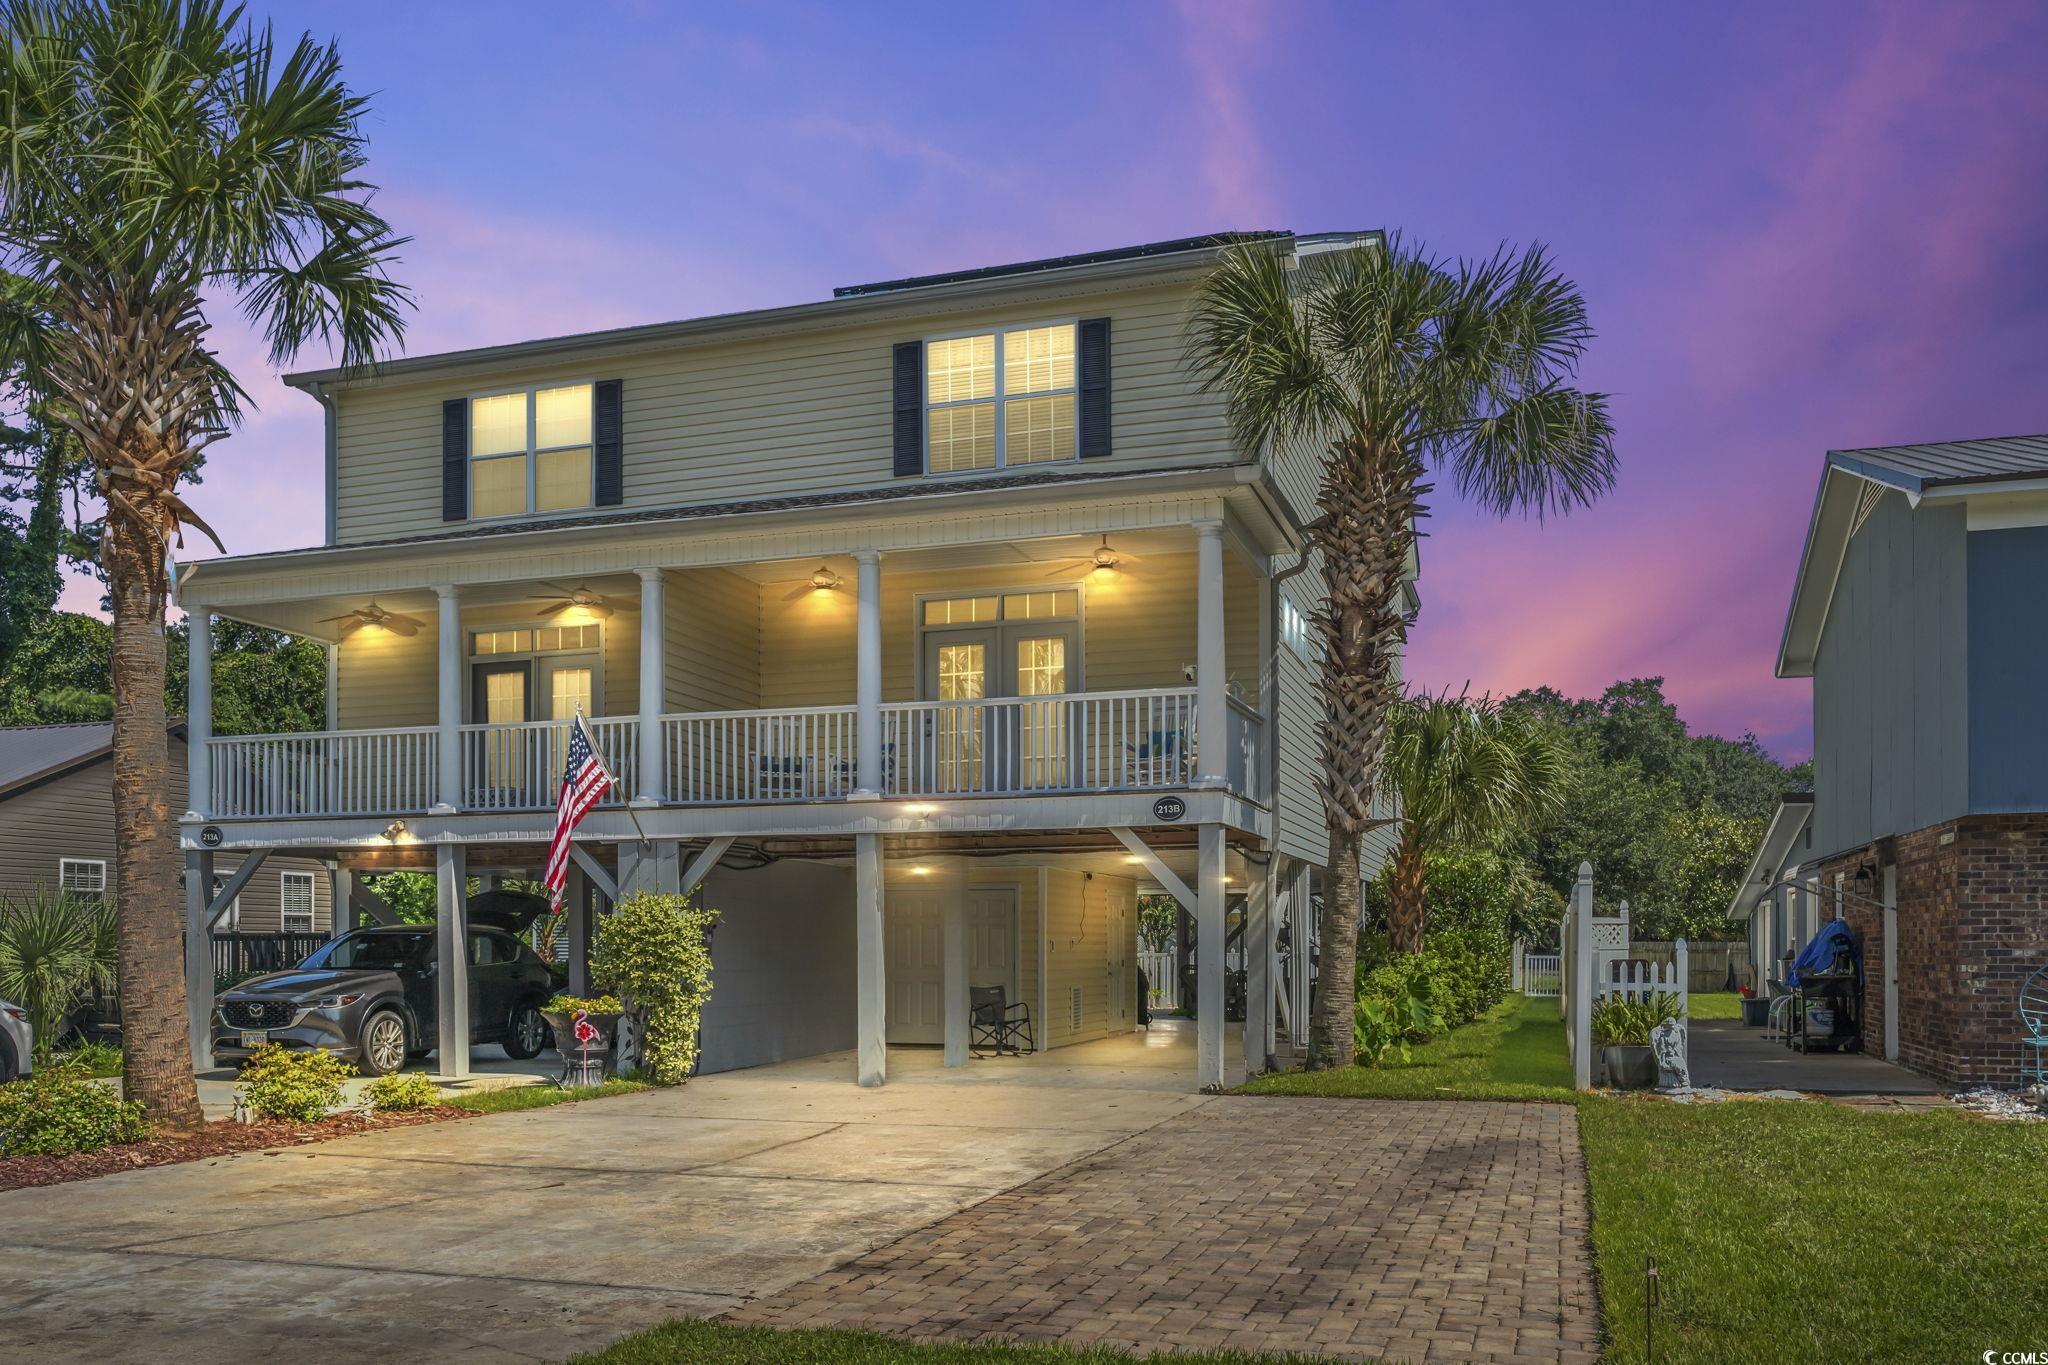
[1188,235,1614,1066]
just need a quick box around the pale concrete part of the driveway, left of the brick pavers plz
[0,1029,1206,1363]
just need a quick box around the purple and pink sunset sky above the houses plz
[68,0,2048,757]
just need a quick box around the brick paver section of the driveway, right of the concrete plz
[731,1097,1597,1361]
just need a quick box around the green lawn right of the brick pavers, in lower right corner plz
[1579,1097,2048,1361]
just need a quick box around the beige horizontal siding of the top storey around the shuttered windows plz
[334,284,1235,542]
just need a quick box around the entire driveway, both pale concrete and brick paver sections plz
[0,1033,1591,1363]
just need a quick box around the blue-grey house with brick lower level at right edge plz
[1736,436,2048,1085]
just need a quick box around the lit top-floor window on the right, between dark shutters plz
[924,323,1077,475]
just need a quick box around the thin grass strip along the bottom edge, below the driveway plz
[571,1318,1315,1365]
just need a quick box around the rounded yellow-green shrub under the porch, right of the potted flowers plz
[590,892,719,1085]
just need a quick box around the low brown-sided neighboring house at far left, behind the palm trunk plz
[0,722,332,933]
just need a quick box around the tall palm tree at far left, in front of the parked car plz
[0,0,408,1132]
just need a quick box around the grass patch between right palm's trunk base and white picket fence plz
[1241,995,1573,1101]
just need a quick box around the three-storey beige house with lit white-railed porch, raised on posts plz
[178,233,1409,1085]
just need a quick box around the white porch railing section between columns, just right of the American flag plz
[662,706,856,806]
